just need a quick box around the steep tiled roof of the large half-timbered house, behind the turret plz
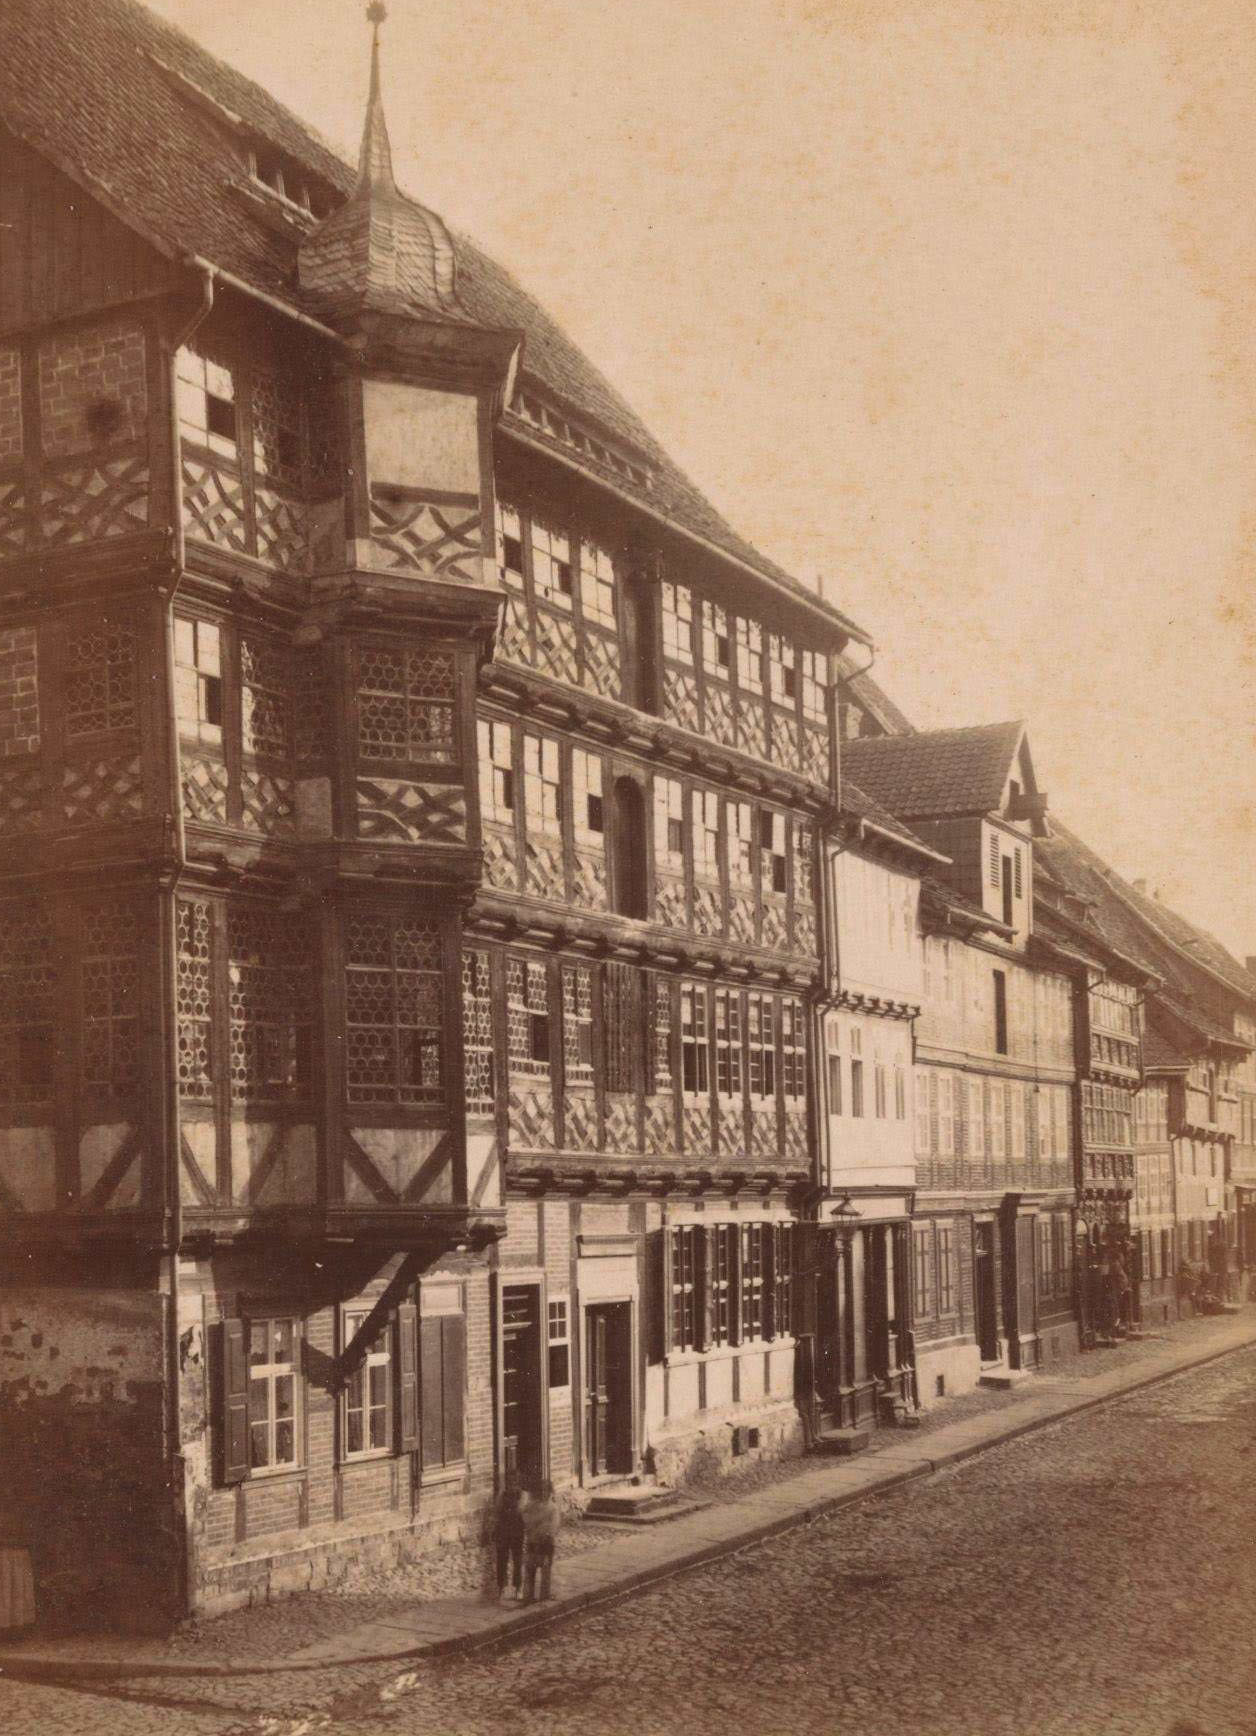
[0,0,866,642]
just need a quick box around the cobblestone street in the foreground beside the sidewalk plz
[0,1349,1256,1736]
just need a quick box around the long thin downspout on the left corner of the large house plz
[160,262,213,1614]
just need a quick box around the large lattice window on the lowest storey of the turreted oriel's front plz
[345,913,444,1104]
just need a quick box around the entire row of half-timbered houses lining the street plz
[0,0,1256,1620]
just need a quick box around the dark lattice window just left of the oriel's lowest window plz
[227,901,314,1102]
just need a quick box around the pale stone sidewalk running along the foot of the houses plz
[0,1305,1256,1682]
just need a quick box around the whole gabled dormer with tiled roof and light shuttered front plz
[841,722,1046,948]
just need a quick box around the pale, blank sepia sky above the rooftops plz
[156,0,1256,957]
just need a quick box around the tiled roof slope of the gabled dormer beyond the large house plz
[841,724,1025,819]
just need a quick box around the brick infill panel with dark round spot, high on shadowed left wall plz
[40,325,147,458]
